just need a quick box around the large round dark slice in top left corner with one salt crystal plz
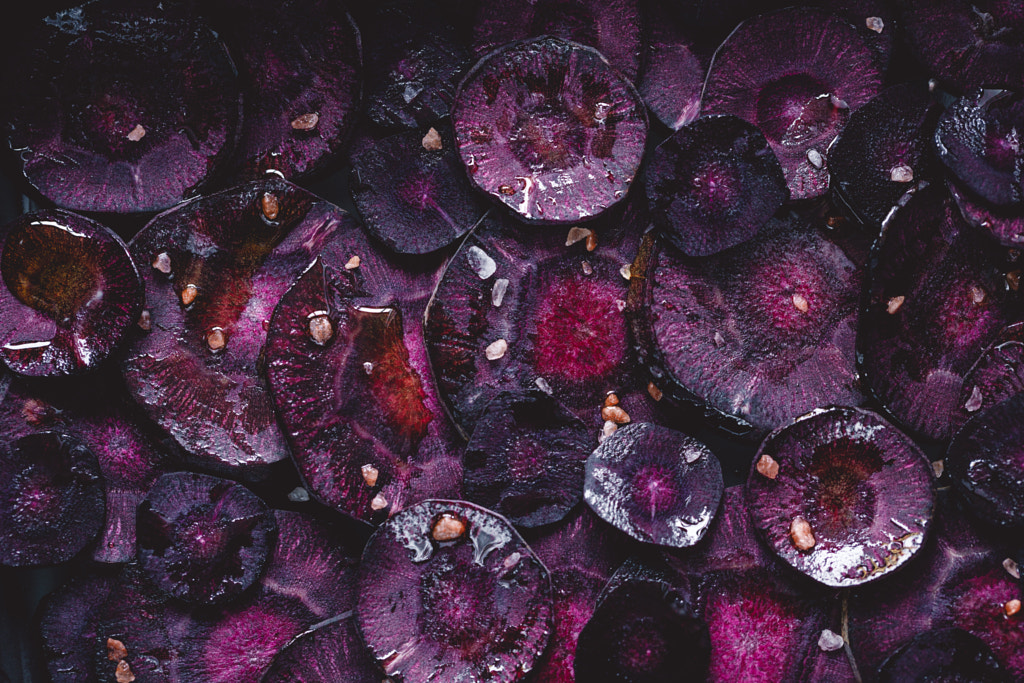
[4,0,242,213]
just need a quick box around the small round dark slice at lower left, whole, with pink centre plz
[138,472,276,605]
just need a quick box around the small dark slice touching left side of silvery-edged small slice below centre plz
[463,390,594,527]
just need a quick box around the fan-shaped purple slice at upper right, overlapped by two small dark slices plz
[701,7,882,200]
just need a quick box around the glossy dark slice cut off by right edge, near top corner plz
[935,90,1024,206]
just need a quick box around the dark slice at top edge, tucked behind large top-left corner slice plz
[214,0,362,180]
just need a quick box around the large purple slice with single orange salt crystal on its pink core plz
[630,217,867,433]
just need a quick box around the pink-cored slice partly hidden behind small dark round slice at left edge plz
[0,372,172,563]
